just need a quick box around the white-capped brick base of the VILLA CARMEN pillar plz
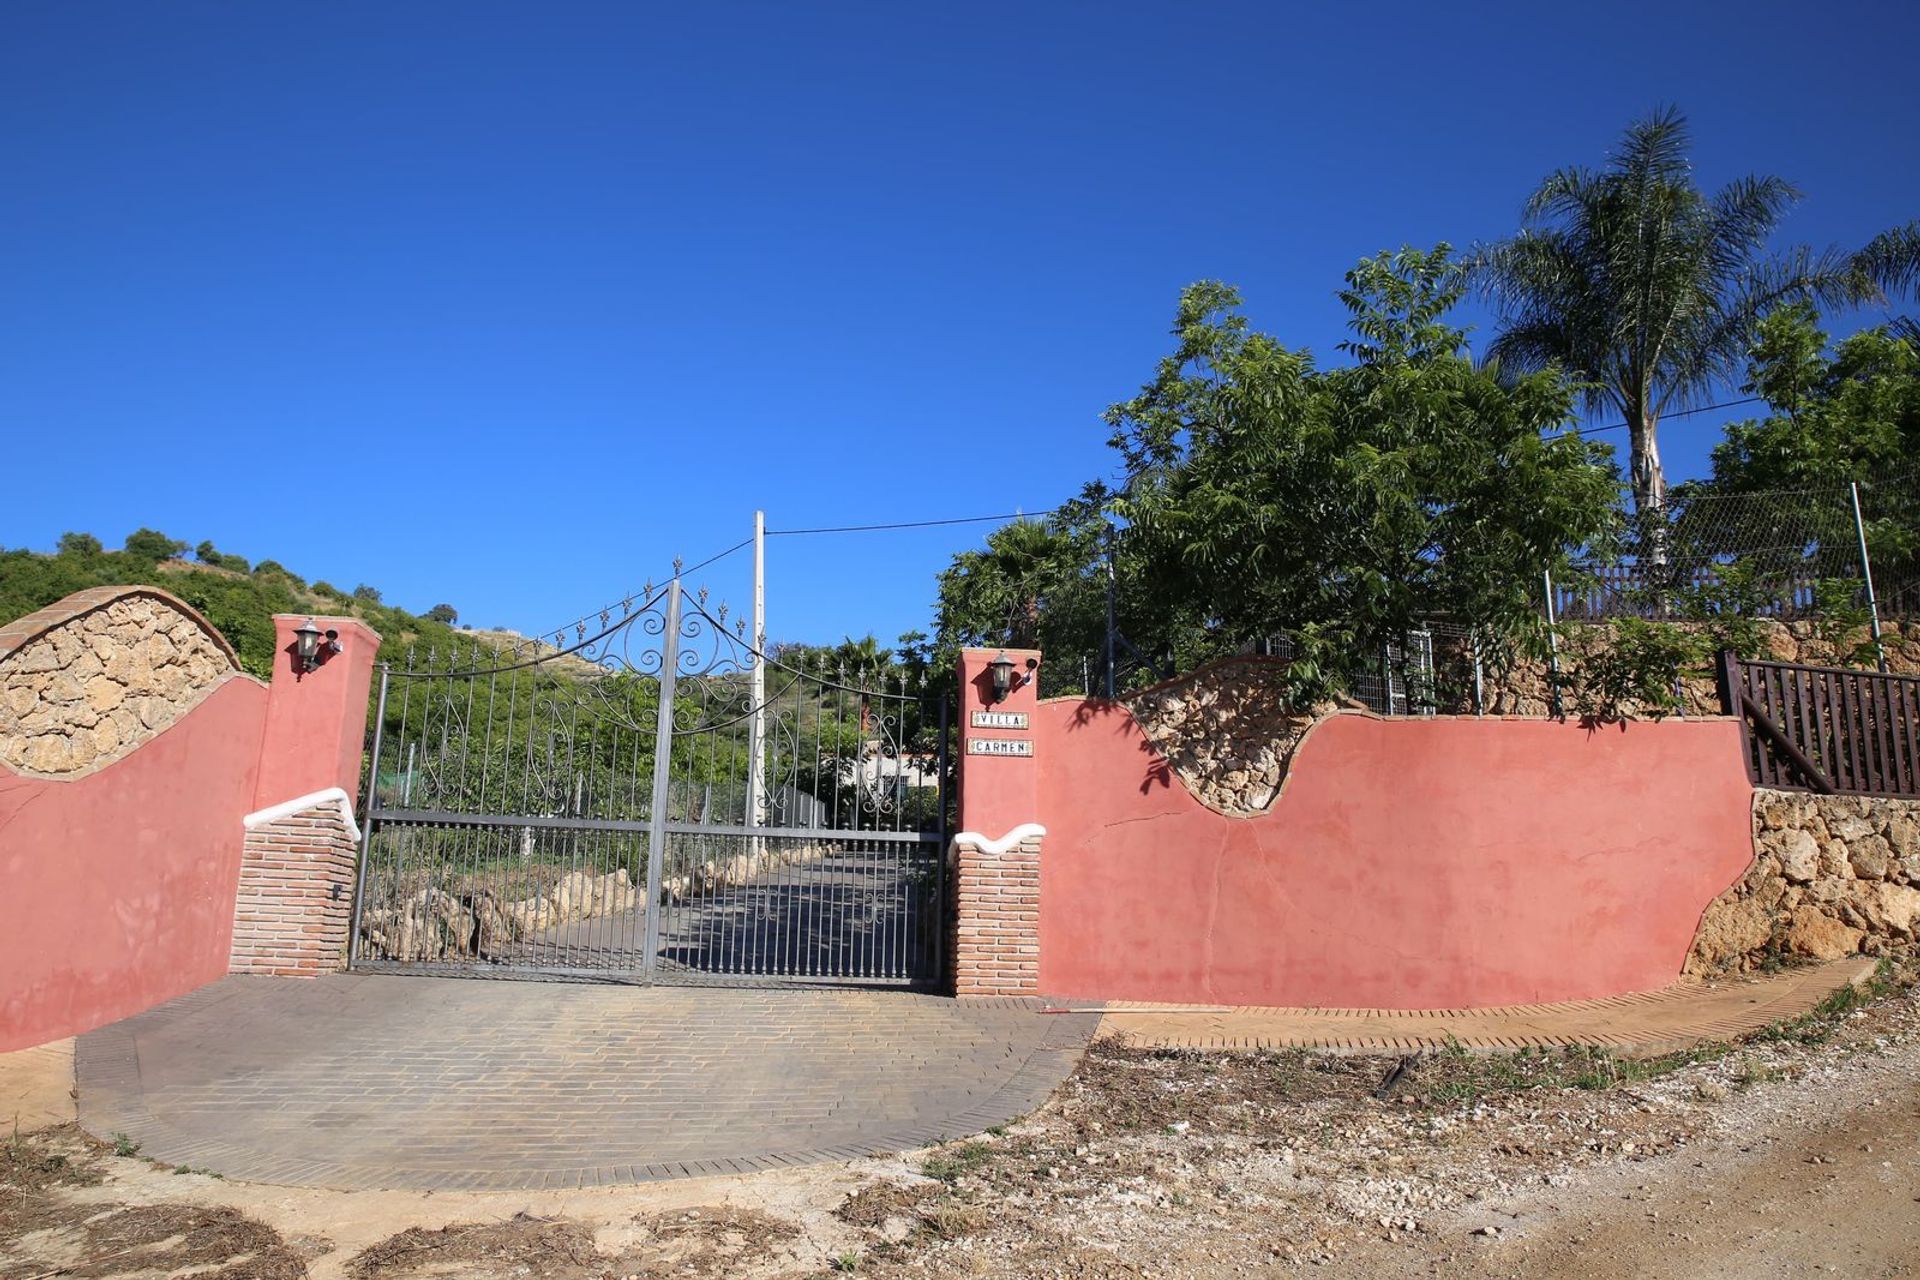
[952,823,1046,1000]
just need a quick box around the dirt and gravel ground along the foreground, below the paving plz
[0,963,1920,1280]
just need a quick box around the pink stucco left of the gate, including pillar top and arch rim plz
[0,587,380,1052]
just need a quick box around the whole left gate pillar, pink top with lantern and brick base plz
[228,614,380,977]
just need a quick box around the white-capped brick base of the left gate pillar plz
[227,791,359,977]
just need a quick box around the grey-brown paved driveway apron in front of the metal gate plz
[77,975,1098,1190]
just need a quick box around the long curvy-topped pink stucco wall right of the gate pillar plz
[1036,699,1753,1009]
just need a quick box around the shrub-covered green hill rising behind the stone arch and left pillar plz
[0,530,480,679]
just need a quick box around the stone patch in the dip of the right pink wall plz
[1121,658,1334,816]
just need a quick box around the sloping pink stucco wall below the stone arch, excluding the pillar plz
[0,676,267,1052]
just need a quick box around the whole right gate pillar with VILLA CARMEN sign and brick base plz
[948,649,1046,998]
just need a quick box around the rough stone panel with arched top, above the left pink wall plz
[0,587,240,777]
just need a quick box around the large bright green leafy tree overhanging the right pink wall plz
[1110,246,1617,693]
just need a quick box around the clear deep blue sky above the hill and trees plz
[0,0,1920,639]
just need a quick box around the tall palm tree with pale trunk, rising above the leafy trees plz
[1476,107,1866,512]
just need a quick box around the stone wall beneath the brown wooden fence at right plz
[1686,791,1920,975]
